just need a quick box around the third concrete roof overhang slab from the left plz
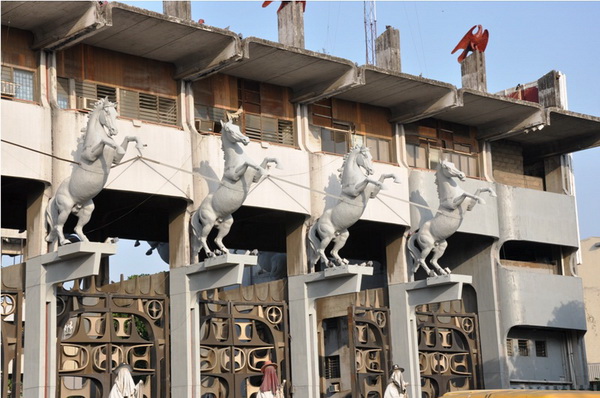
[219,37,364,104]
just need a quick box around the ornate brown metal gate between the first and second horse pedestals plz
[57,273,170,398]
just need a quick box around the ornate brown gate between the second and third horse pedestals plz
[199,286,290,398]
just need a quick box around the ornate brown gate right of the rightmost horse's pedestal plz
[416,300,482,398]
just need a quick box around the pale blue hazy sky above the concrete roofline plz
[3,0,600,273]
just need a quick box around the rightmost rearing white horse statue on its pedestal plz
[407,160,496,276]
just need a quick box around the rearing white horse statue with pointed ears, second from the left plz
[190,109,279,257]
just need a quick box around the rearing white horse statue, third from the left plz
[308,145,400,272]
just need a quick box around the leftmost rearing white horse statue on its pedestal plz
[46,98,145,245]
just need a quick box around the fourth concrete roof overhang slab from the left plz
[336,65,459,123]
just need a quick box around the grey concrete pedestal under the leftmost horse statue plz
[23,242,117,398]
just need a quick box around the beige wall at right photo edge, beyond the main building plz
[577,237,600,363]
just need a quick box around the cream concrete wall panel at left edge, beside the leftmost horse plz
[1,100,51,183]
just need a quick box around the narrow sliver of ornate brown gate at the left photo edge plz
[0,264,24,398]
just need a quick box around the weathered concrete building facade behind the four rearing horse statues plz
[1,2,600,398]
